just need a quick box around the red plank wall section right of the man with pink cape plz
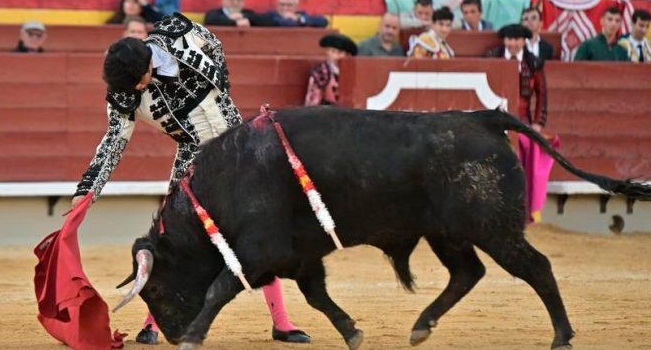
[546,62,651,180]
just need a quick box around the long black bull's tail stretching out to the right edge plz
[478,111,651,201]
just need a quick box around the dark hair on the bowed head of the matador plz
[102,38,151,92]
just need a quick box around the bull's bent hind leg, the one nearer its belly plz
[409,237,486,345]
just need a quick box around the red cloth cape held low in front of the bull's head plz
[34,192,124,350]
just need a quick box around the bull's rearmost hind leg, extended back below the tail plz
[477,236,574,350]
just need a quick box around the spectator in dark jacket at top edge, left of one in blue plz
[205,0,274,27]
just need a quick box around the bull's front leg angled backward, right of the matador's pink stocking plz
[296,260,364,350]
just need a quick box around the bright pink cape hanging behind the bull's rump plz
[518,134,561,223]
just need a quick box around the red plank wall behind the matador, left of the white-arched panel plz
[0,53,318,181]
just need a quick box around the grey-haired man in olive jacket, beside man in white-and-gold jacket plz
[359,12,405,56]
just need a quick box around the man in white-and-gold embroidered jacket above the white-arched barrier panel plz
[407,6,454,59]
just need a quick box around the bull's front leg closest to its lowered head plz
[179,268,244,350]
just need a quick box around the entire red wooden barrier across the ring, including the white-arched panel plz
[0,53,651,182]
